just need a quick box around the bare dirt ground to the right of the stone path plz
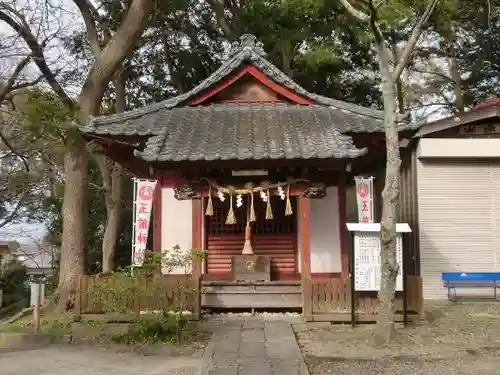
[294,303,500,375]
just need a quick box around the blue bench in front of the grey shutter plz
[441,272,500,301]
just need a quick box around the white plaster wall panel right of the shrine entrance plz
[297,186,342,273]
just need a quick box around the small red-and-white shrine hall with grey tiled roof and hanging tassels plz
[80,34,414,308]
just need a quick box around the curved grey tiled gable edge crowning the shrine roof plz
[81,34,390,135]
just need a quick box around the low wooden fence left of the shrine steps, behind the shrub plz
[73,275,201,319]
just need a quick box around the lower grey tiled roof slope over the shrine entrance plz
[133,104,368,161]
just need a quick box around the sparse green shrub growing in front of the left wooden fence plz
[92,246,205,344]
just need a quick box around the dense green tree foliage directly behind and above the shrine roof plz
[66,0,380,108]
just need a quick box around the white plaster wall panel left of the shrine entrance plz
[161,188,193,274]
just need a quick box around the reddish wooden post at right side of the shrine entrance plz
[298,195,312,321]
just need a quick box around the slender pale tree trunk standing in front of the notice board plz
[375,44,401,344]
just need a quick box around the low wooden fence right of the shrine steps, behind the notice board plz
[303,276,423,321]
